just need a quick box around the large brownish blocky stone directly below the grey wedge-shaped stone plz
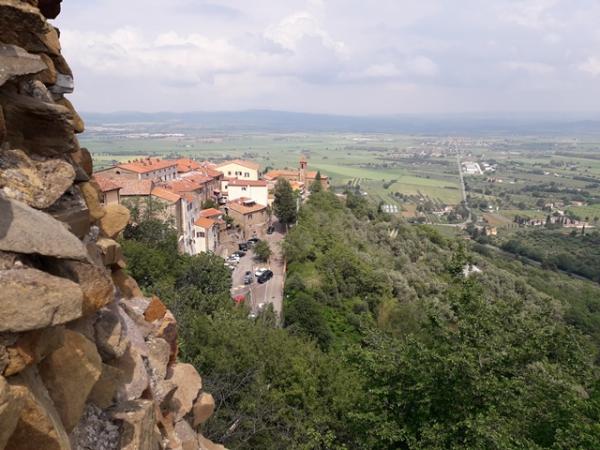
[0,269,83,332]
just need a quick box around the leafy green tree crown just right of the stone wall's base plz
[181,310,362,450]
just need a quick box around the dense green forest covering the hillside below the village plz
[123,192,600,449]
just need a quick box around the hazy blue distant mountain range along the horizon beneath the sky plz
[82,110,600,135]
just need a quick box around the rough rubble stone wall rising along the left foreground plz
[0,0,223,450]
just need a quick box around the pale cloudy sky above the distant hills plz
[54,0,600,115]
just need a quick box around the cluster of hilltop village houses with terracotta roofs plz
[93,157,329,255]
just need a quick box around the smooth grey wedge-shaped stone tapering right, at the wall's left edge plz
[0,196,87,260]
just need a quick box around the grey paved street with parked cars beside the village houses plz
[231,223,285,315]
